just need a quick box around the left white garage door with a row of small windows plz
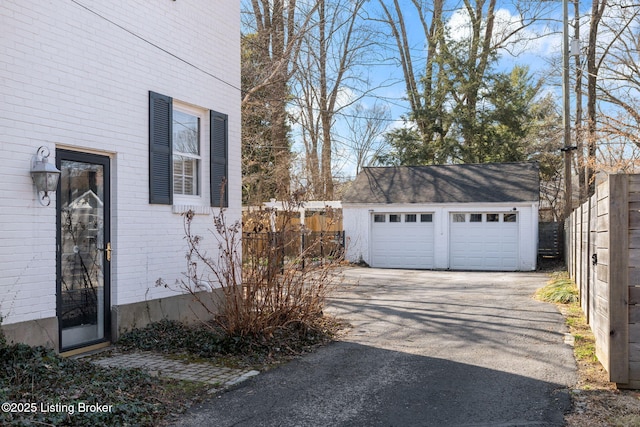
[371,213,434,268]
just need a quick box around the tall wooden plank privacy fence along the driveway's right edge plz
[565,175,640,388]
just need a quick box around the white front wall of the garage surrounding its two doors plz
[342,202,538,271]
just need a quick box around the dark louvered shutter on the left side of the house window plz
[149,92,173,205]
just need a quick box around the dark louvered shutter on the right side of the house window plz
[210,111,229,208]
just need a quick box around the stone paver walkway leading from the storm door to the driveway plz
[91,351,260,388]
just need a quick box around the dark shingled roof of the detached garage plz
[342,163,540,204]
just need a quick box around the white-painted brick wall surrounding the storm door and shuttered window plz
[0,0,241,323]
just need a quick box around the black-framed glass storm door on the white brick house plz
[56,150,111,351]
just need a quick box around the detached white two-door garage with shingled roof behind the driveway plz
[342,163,539,271]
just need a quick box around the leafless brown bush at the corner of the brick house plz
[159,196,342,337]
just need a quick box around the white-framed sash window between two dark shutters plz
[172,104,202,196]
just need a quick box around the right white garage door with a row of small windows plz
[449,212,519,271]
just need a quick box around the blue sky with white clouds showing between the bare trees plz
[286,0,590,183]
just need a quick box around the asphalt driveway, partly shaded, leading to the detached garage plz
[176,268,576,427]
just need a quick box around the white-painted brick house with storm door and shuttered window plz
[0,0,241,352]
